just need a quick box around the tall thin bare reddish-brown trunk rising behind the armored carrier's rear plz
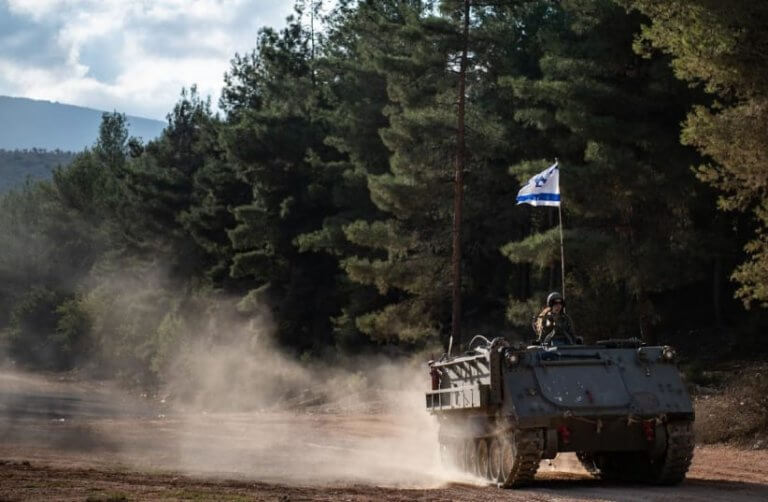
[451,0,471,346]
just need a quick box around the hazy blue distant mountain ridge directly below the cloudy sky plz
[0,96,166,152]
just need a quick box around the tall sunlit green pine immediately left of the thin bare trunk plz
[344,2,464,341]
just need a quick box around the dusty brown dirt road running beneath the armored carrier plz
[0,373,768,501]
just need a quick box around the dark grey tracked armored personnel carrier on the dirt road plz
[426,337,694,488]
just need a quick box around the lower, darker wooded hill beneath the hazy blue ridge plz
[0,149,75,194]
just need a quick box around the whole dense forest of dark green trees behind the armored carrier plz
[0,0,768,384]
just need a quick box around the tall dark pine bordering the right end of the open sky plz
[221,9,338,351]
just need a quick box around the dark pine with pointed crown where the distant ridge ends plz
[118,86,240,285]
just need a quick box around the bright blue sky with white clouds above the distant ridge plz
[0,0,294,119]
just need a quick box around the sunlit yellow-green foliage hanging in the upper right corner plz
[619,0,768,307]
